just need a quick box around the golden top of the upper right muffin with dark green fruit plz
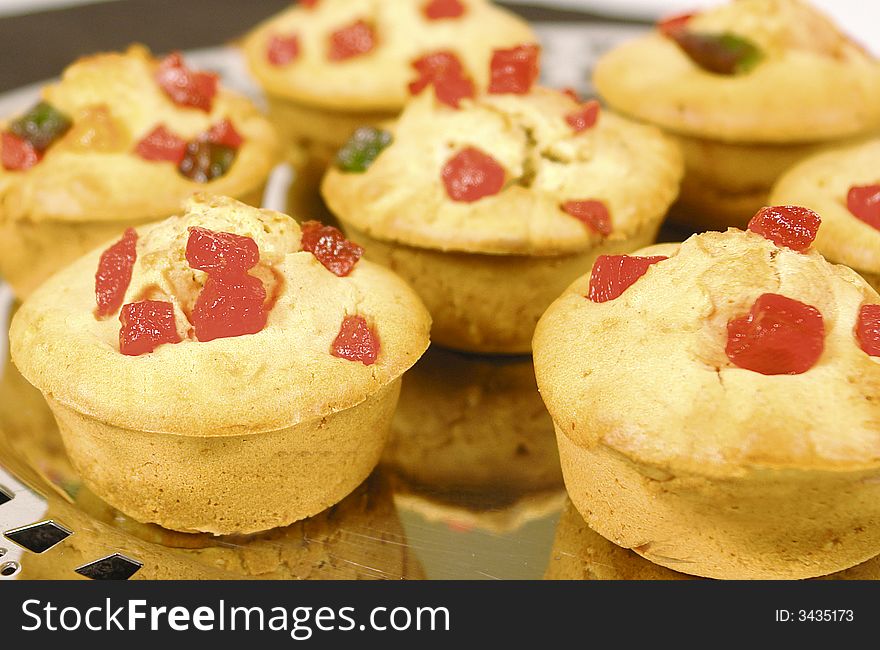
[594,0,880,142]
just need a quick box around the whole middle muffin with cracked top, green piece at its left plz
[322,71,682,354]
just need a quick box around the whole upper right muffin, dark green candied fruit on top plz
[593,0,880,229]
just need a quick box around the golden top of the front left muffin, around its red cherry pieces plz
[10,197,430,436]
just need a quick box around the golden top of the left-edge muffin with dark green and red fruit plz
[0,46,279,221]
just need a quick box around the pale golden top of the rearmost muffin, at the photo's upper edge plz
[243,0,537,112]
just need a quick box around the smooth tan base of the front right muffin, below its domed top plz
[557,426,880,580]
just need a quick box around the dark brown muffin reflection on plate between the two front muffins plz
[382,347,562,529]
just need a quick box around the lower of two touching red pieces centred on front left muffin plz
[192,273,269,342]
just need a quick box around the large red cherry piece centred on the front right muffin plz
[726,293,825,375]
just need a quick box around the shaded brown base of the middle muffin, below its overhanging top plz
[343,223,659,354]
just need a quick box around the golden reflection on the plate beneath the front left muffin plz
[15,472,423,580]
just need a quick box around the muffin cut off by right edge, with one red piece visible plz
[770,140,880,290]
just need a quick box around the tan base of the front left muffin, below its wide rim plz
[46,379,400,535]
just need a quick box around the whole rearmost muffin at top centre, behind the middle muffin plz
[242,0,536,215]
